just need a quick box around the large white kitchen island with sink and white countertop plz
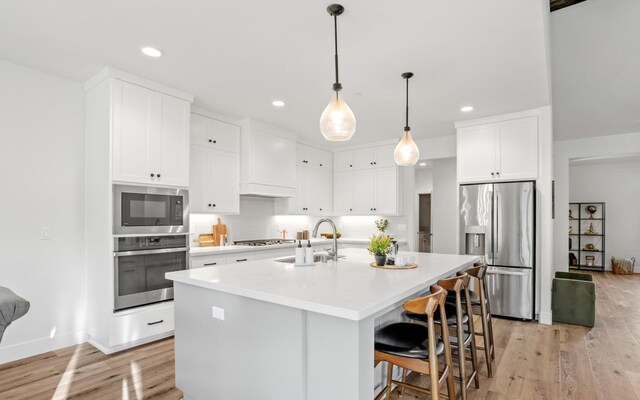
[166,249,478,400]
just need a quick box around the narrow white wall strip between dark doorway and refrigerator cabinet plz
[431,158,458,254]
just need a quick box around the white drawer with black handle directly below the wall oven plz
[110,302,173,346]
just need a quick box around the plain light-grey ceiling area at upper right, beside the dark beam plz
[551,0,640,140]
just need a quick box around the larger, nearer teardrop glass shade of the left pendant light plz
[320,91,356,142]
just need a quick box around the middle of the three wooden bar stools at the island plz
[406,273,480,400]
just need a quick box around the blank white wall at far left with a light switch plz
[0,60,85,363]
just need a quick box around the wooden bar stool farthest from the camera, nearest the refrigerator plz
[447,263,495,378]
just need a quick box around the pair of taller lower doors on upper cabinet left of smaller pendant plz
[334,167,402,215]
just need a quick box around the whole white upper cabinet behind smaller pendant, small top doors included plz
[333,145,402,215]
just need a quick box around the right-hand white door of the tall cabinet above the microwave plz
[155,94,191,186]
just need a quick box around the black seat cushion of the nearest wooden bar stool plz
[375,322,444,359]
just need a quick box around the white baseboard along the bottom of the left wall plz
[0,329,87,364]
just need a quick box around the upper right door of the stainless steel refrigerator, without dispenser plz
[493,182,535,268]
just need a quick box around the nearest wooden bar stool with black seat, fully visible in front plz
[374,285,456,400]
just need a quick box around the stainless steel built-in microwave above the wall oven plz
[113,185,189,235]
